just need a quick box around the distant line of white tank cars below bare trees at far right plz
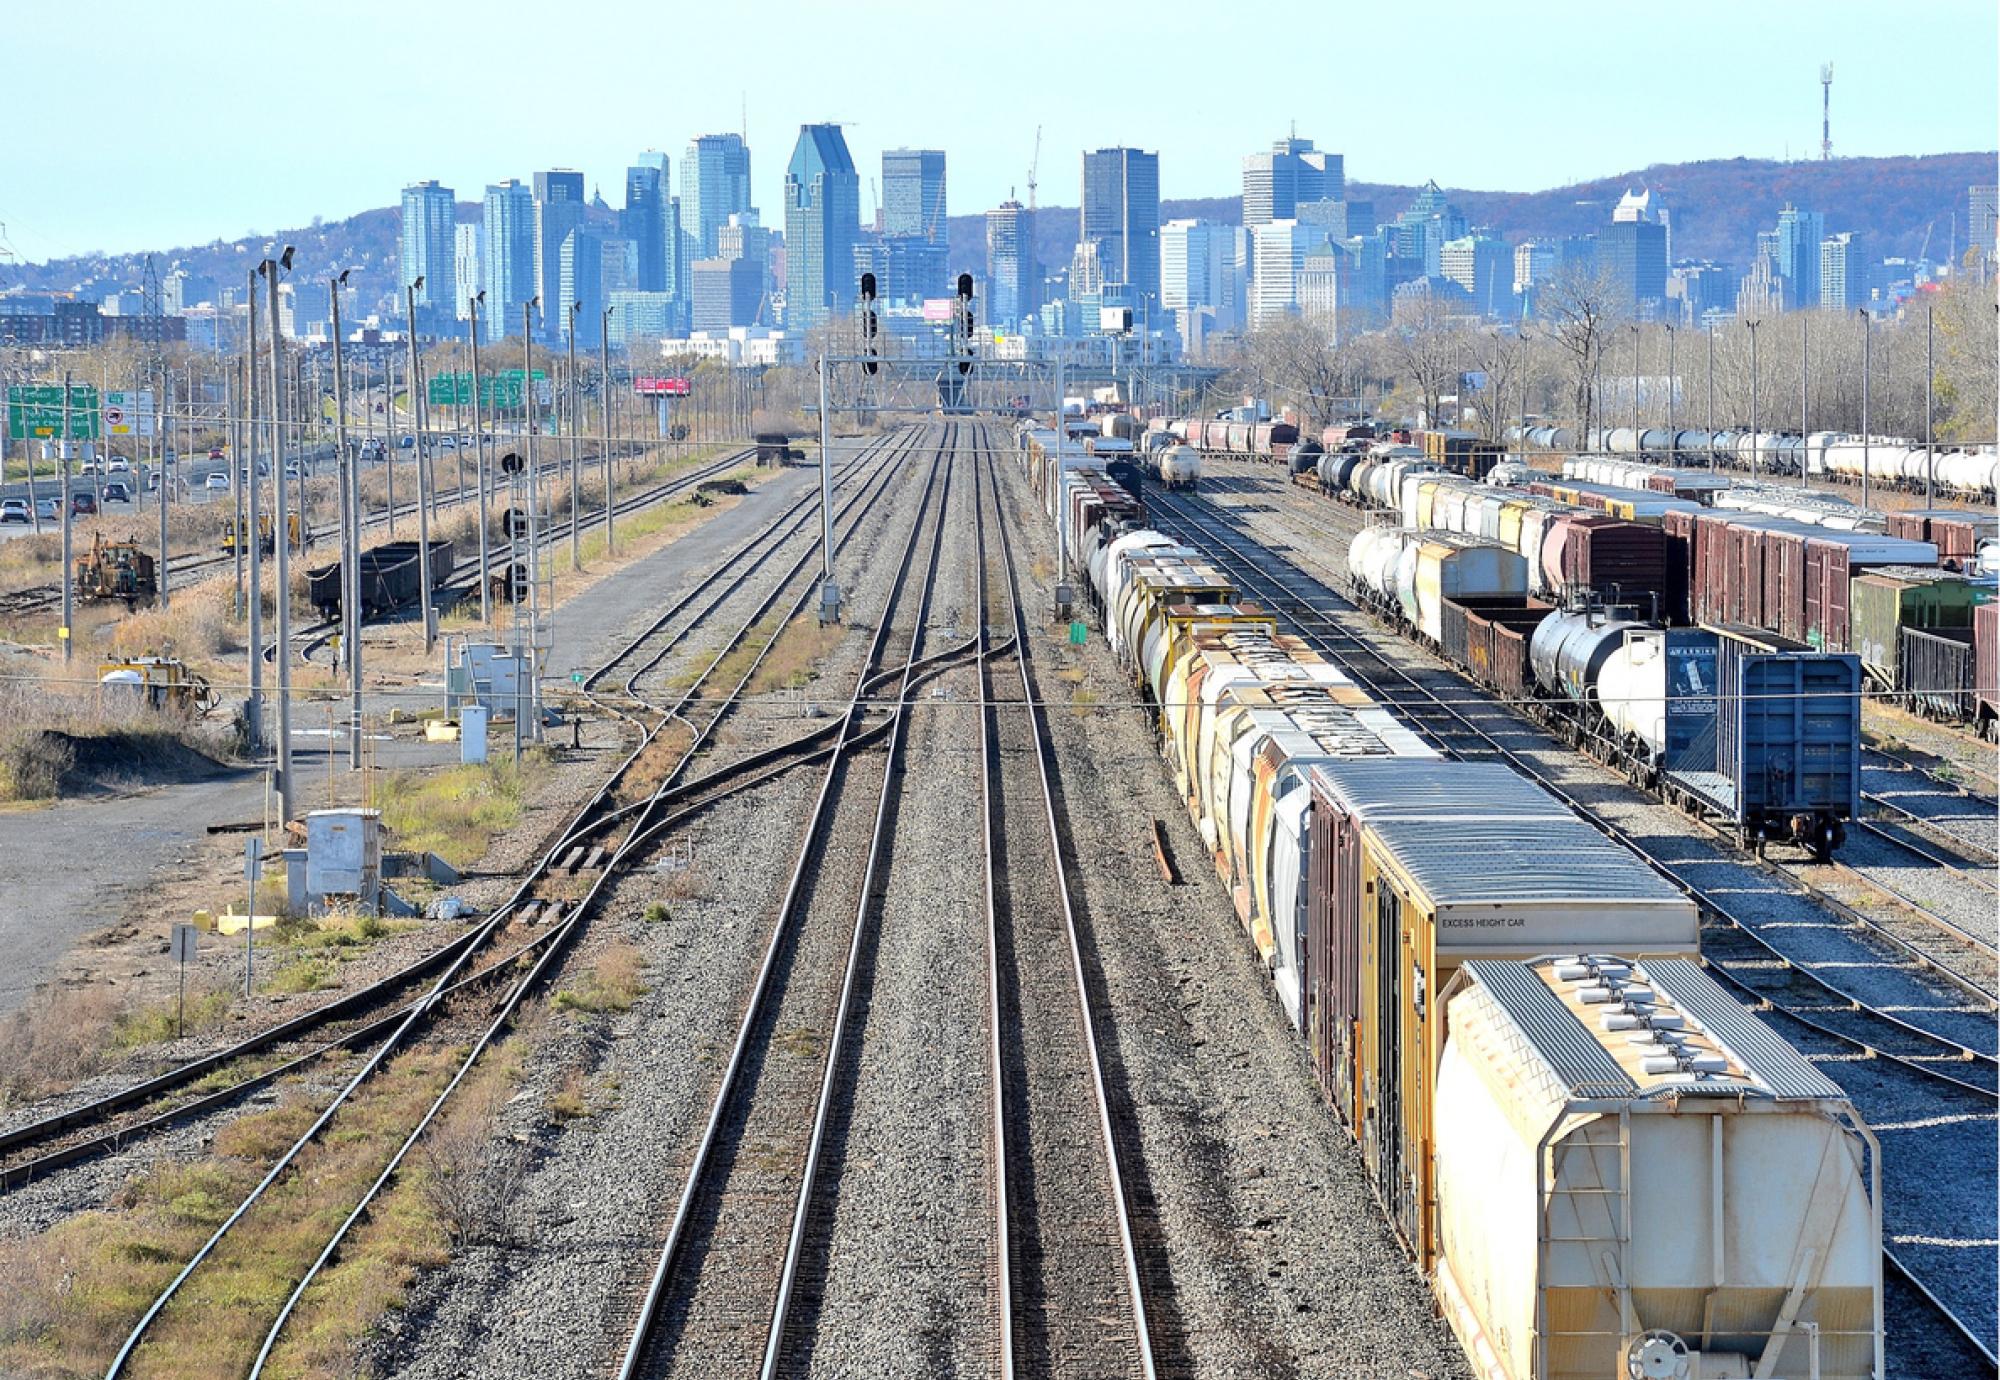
[1508,426,2000,498]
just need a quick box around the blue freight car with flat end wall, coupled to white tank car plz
[1668,628,1862,860]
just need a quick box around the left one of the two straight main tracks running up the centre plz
[618,430,968,1380]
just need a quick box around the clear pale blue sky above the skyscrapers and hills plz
[0,0,2000,260]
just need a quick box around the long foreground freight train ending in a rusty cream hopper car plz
[1020,422,1882,1380]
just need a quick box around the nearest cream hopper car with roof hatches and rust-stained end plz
[1436,956,1882,1380]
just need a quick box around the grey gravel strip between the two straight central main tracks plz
[788,438,994,1376]
